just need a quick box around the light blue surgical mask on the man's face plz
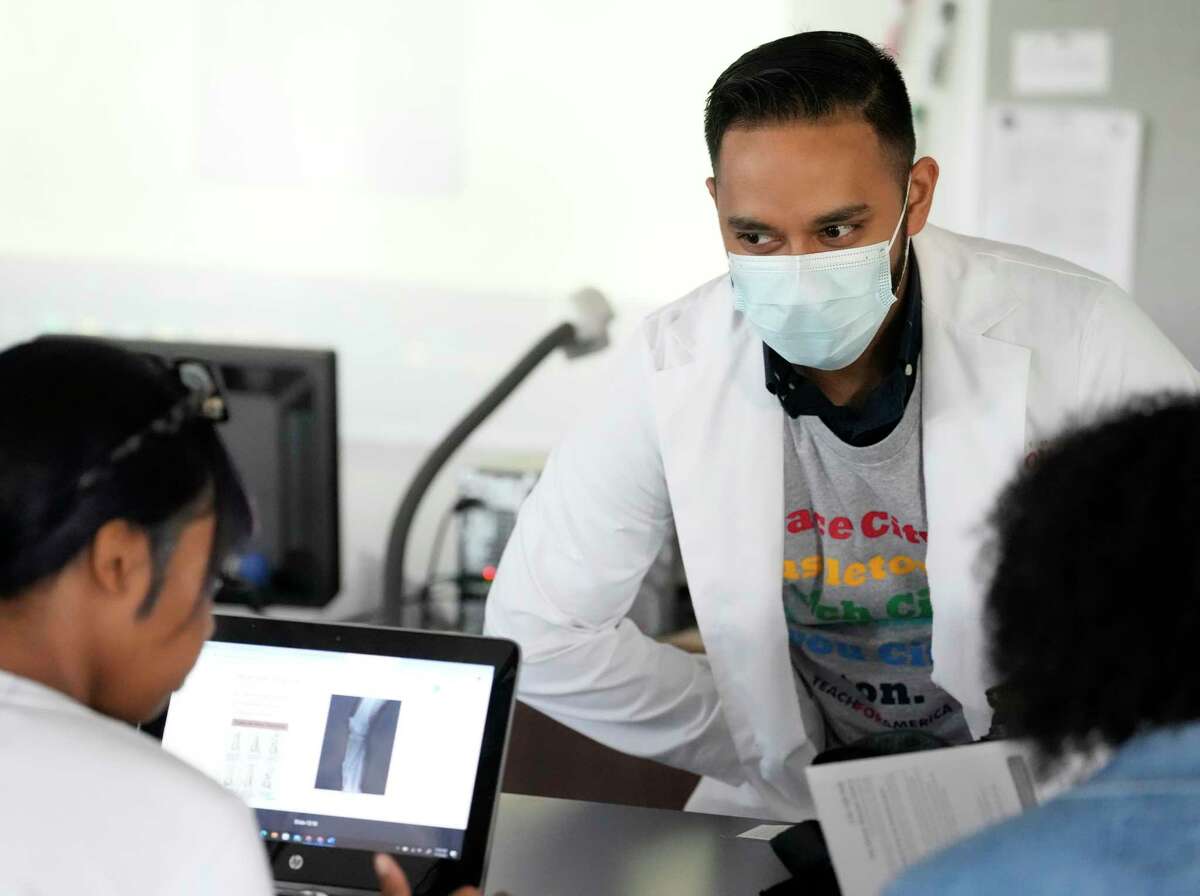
[730,181,912,371]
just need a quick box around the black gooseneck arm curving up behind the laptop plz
[383,324,576,625]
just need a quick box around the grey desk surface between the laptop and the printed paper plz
[487,793,788,896]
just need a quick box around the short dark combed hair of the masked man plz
[704,31,917,184]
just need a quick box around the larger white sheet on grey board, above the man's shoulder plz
[982,103,1142,290]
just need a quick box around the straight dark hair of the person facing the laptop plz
[0,337,251,614]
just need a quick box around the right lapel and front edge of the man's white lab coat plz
[913,227,1031,736]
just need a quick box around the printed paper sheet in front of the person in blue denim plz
[806,741,1042,896]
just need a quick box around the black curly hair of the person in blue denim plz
[984,397,1200,759]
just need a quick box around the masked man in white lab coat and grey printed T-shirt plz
[487,32,1200,819]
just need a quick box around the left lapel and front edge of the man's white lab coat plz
[654,284,823,806]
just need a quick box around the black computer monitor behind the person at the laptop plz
[112,339,341,607]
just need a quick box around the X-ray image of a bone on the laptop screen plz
[316,693,400,796]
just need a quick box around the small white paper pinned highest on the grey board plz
[1012,28,1112,95]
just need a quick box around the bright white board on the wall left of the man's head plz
[0,0,806,314]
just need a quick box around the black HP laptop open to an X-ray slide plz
[146,615,518,896]
